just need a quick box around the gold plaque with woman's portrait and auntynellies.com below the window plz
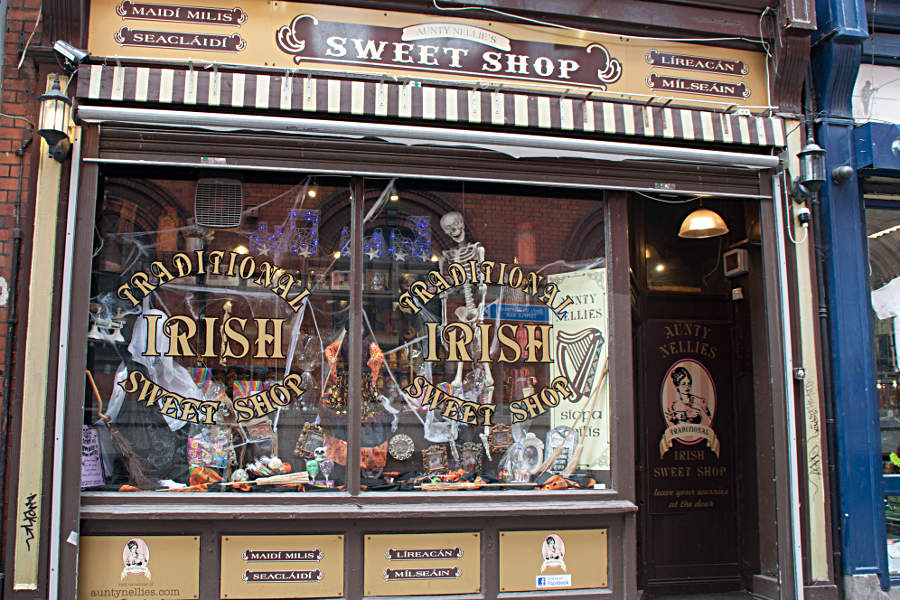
[78,535,200,600]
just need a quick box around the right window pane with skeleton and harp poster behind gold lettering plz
[361,180,610,491]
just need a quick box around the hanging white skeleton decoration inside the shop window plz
[438,211,494,403]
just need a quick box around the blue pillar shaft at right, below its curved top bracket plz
[817,120,888,588]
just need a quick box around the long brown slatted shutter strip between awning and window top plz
[91,126,761,196]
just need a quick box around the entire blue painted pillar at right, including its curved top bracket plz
[812,0,889,588]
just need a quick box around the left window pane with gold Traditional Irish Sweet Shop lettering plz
[83,176,349,492]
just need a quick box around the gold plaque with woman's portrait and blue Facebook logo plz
[500,529,608,592]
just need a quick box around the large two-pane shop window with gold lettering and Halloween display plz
[82,172,612,493]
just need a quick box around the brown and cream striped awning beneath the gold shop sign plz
[76,65,785,147]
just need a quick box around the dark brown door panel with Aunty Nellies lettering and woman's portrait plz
[638,319,747,591]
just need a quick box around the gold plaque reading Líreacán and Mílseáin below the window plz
[365,532,481,596]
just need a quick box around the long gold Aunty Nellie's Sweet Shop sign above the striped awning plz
[89,0,768,110]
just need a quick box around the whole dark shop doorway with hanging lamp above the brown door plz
[629,194,765,595]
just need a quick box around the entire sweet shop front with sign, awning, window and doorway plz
[0,1,830,598]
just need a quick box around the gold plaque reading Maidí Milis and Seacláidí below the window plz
[219,535,344,600]
